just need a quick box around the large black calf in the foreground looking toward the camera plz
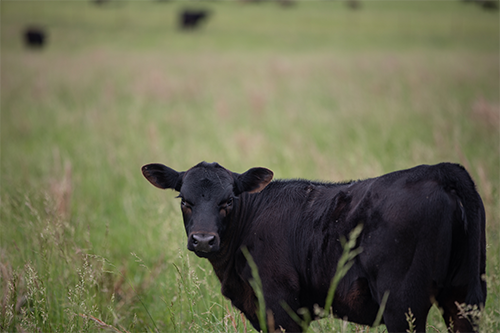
[142,162,486,333]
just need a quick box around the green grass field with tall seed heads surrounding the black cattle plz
[0,0,500,332]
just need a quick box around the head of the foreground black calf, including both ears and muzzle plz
[142,162,273,257]
